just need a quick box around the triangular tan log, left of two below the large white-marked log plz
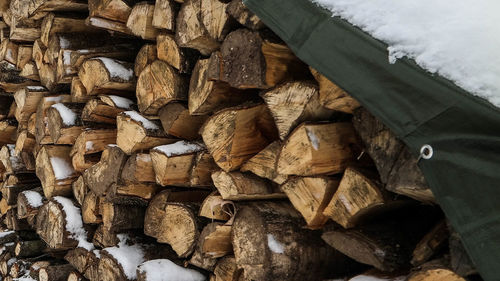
[281,177,339,229]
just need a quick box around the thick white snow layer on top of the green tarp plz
[312,0,500,106]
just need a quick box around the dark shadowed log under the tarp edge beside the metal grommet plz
[352,109,435,203]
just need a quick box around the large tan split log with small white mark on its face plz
[277,123,360,176]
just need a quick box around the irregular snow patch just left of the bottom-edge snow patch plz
[103,236,145,280]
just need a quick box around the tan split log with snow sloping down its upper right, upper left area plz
[78,57,136,95]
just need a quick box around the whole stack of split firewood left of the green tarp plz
[0,0,475,281]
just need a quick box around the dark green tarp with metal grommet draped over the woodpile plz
[244,0,500,281]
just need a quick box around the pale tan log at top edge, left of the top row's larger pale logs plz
[127,2,159,40]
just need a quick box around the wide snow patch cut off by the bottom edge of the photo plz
[138,259,206,281]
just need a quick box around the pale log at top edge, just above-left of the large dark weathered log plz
[175,0,220,55]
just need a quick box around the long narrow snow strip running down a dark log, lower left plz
[54,196,94,251]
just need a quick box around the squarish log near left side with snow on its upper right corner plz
[46,103,85,144]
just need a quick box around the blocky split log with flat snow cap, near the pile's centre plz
[151,141,206,186]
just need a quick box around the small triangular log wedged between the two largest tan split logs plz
[240,141,287,184]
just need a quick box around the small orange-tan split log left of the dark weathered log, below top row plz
[156,32,200,73]
